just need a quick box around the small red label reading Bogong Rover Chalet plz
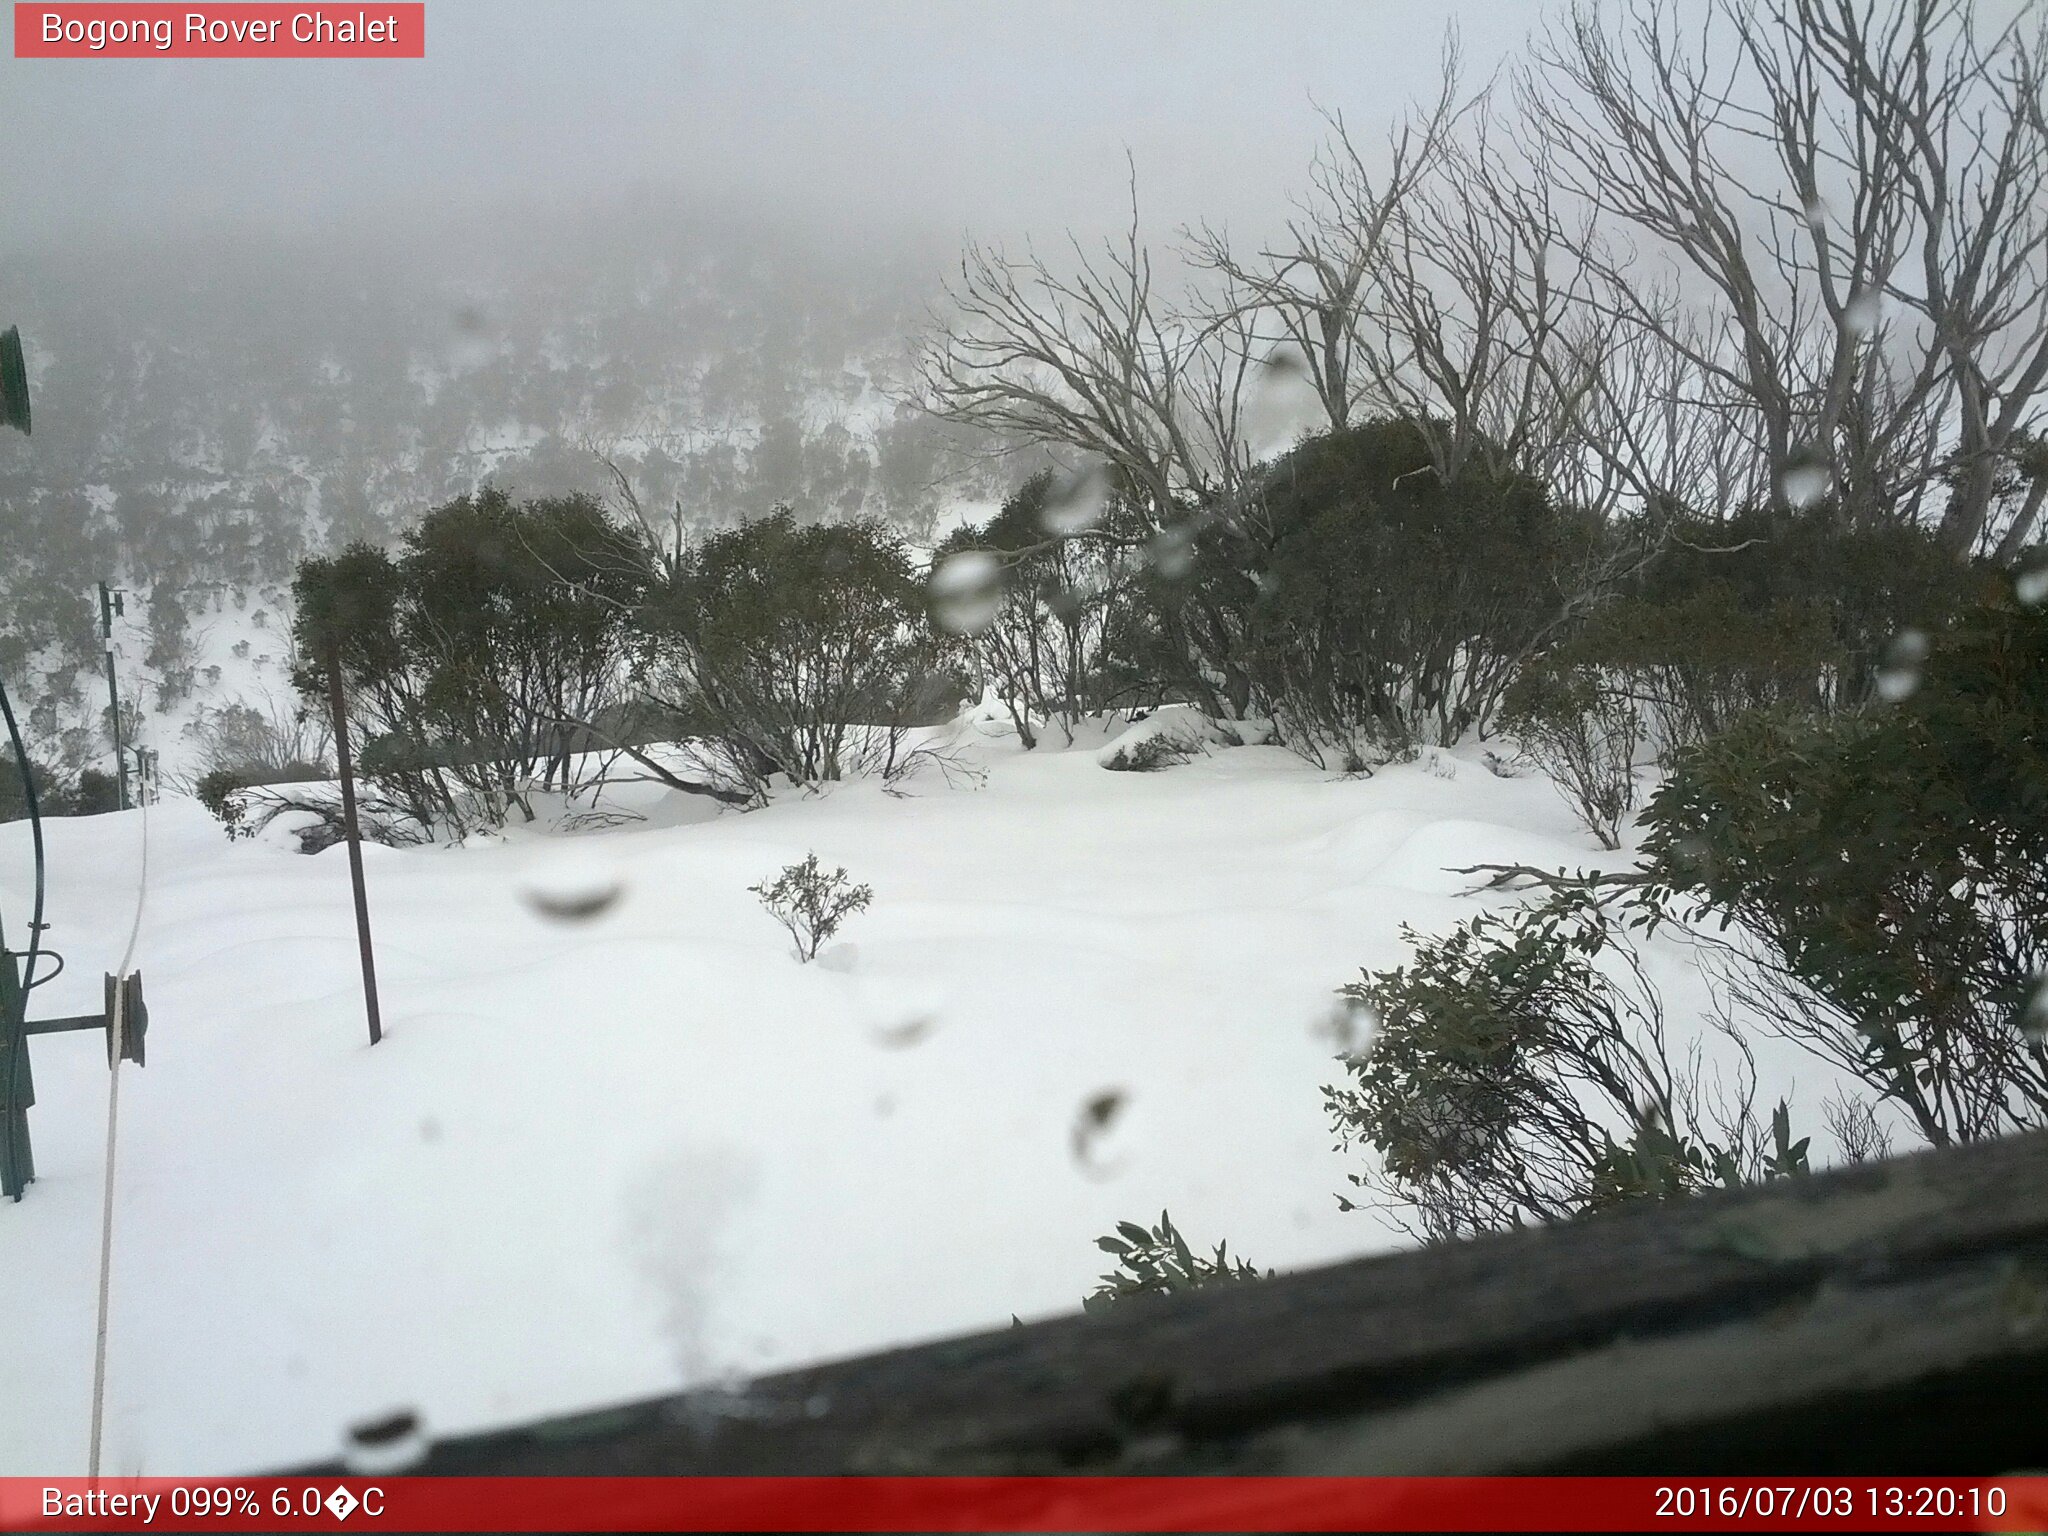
[14,0,426,59]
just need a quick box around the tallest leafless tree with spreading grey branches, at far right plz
[1518,0,2048,551]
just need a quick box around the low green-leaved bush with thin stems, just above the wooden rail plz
[1323,887,1806,1237]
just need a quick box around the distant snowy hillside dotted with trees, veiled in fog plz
[0,195,1022,774]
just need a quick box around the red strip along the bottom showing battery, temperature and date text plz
[0,1477,2048,1532]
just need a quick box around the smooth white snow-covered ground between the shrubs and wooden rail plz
[0,727,1826,1475]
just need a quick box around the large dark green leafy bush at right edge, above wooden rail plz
[1645,581,2048,1145]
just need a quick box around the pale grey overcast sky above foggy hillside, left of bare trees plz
[0,0,1538,248]
